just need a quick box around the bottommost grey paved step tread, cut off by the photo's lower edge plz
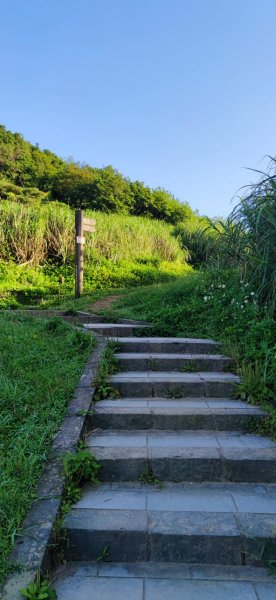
[54,559,276,600]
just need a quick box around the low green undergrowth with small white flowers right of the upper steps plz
[113,268,276,426]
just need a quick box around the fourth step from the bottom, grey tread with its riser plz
[93,398,266,431]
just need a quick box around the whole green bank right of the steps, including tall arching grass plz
[104,160,276,437]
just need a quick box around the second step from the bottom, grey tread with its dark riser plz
[63,484,276,566]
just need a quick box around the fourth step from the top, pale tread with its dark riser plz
[110,371,240,398]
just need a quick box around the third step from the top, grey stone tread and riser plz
[115,352,232,372]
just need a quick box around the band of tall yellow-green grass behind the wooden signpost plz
[0,202,184,265]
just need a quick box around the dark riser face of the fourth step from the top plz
[113,380,237,398]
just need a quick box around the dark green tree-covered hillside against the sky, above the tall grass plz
[0,125,196,225]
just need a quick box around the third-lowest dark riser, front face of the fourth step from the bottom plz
[93,411,262,431]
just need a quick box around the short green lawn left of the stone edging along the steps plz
[0,314,95,581]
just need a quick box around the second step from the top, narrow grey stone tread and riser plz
[111,336,220,354]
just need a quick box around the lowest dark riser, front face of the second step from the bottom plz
[61,529,276,566]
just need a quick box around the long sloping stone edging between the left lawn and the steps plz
[0,332,107,600]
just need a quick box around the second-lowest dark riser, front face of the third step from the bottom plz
[92,458,276,483]
